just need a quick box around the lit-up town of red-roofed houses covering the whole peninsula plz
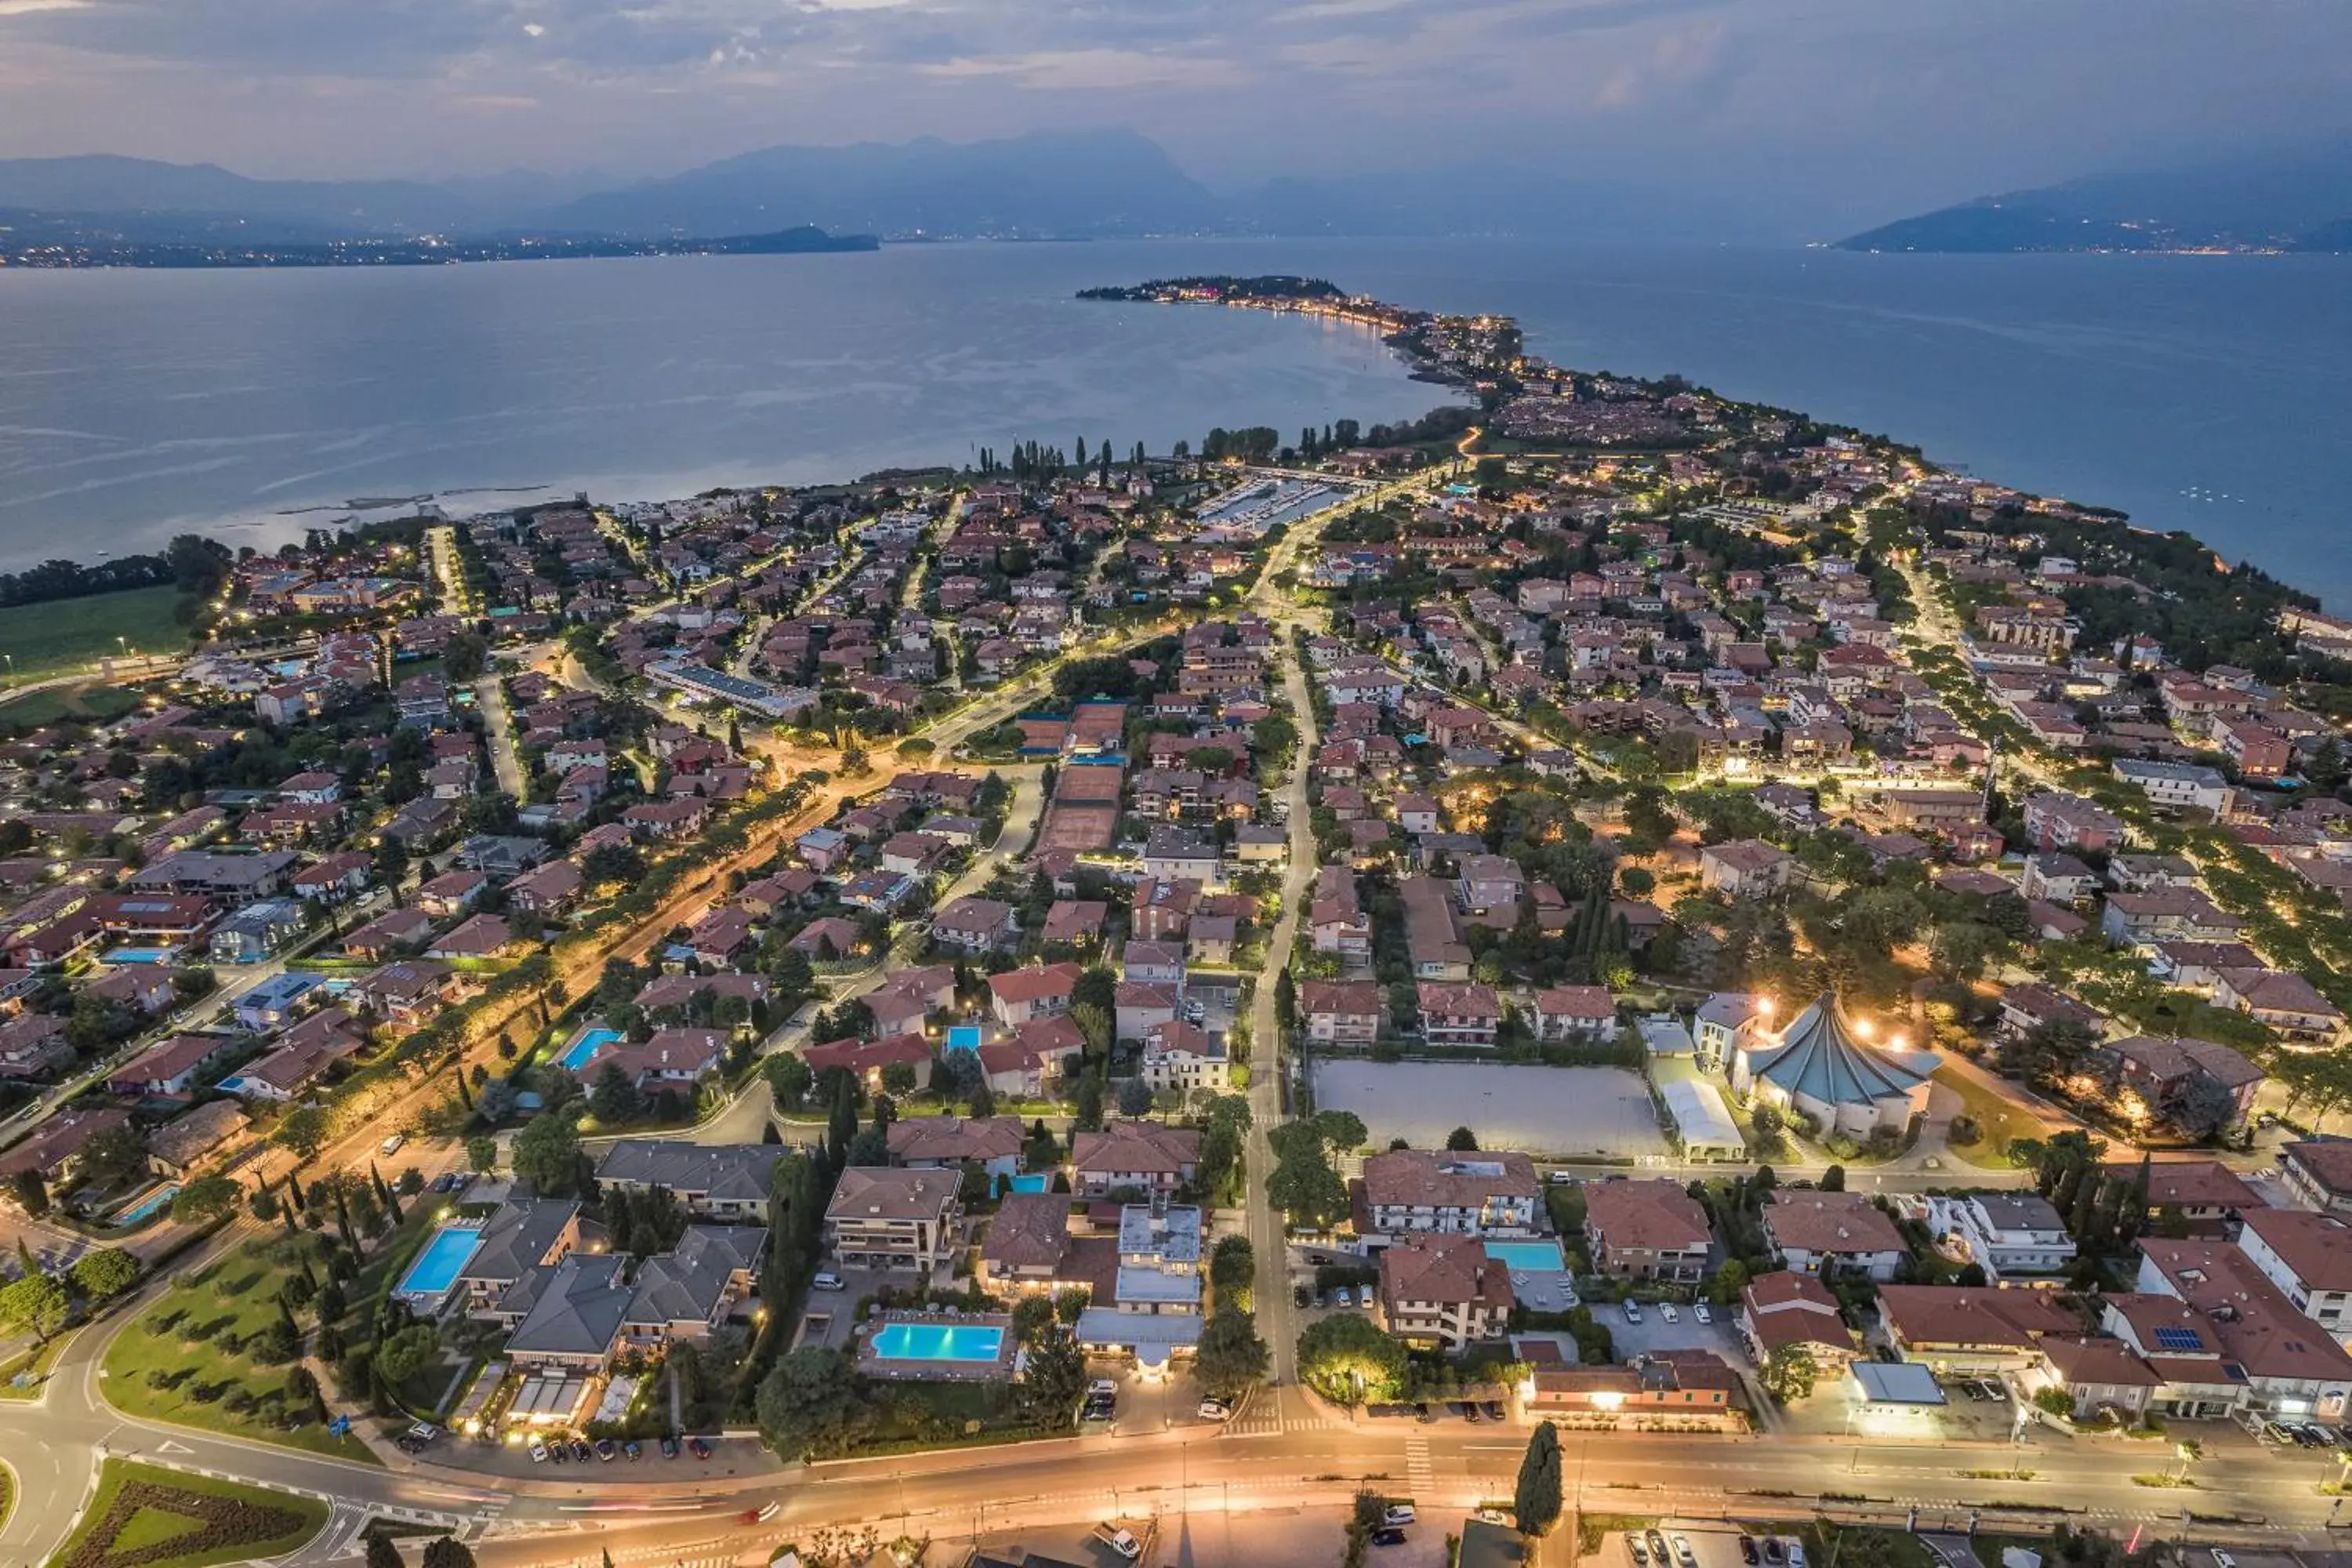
[0,278,2352,1568]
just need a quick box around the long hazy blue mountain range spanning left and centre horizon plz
[0,129,1792,252]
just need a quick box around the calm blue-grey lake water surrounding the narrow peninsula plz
[0,240,2352,607]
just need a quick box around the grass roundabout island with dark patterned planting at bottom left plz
[49,1460,327,1568]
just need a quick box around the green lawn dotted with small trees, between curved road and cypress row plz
[103,1236,379,1465]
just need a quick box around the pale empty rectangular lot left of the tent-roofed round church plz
[1315,1060,1665,1159]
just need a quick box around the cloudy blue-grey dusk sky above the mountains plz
[0,0,2352,219]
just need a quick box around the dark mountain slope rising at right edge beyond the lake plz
[1837,139,2352,254]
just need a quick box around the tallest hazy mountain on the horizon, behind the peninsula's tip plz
[534,132,1225,235]
